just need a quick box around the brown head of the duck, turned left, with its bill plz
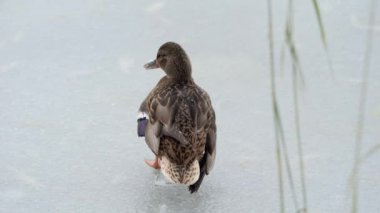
[144,42,191,80]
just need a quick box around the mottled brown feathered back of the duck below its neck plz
[148,79,214,165]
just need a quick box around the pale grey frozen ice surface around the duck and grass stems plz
[0,0,380,213]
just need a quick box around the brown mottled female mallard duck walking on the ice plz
[138,42,216,193]
